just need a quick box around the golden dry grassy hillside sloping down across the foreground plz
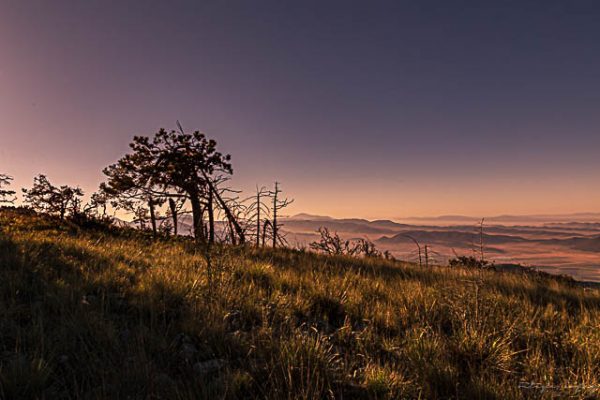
[0,211,600,399]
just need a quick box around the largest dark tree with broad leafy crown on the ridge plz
[104,125,244,242]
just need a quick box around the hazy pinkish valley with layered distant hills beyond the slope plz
[283,213,600,282]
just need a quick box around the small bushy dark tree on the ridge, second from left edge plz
[23,174,83,219]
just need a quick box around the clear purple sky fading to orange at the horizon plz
[0,0,600,219]
